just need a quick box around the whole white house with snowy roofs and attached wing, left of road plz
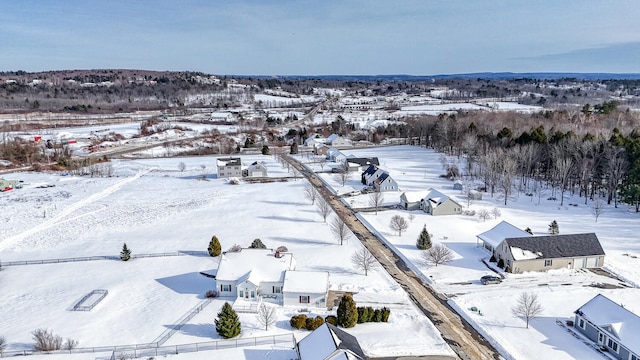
[216,248,329,307]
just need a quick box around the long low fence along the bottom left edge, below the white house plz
[0,333,296,360]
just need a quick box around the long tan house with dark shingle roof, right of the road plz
[494,233,605,273]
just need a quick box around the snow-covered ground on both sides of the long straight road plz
[0,146,640,360]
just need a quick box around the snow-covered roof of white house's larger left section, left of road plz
[216,249,295,283]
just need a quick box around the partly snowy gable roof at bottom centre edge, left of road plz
[298,323,366,360]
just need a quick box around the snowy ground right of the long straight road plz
[302,146,640,359]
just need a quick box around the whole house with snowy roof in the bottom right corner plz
[573,294,640,360]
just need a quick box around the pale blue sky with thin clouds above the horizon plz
[0,0,640,75]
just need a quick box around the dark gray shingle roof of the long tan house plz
[505,233,604,259]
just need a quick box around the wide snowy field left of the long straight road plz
[0,152,452,360]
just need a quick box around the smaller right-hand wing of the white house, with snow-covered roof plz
[282,271,329,308]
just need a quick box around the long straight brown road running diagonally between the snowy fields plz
[284,156,502,360]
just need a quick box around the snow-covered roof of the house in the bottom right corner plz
[576,294,640,354]
